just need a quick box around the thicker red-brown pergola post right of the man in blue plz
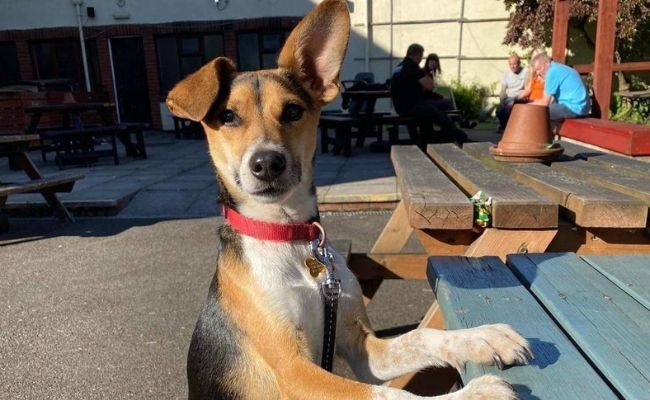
[592,0,618,119]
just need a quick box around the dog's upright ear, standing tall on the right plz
[278,0,350,103]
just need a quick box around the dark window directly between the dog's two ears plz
[237,32,287,71]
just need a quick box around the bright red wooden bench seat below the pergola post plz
[559,118,650,156]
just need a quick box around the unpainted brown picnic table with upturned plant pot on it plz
[350,142,650,394]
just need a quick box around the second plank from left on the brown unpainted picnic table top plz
[427,143,558,229]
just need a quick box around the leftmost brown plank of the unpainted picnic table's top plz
[391,146,474,229]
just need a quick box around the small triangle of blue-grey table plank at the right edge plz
[582,255,650,310]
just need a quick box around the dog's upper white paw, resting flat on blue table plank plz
[456,324,534,369]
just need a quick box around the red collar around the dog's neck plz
[223,206,324,242]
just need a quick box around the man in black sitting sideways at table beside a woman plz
[390,43,467,149]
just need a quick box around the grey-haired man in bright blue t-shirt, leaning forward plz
[532,53,590,123]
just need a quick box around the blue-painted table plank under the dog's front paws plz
[427,256,617,399]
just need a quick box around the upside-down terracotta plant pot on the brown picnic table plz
[490,104,564,162]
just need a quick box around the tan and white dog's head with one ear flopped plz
[167,0,350,220]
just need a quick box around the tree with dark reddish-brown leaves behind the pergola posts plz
[499,0,650,61]
